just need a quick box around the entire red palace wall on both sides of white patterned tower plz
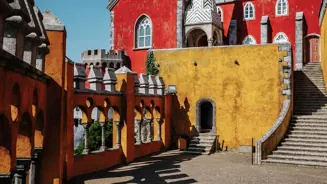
[112,0,321,73]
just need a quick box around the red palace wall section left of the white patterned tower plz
[112,0,177,73]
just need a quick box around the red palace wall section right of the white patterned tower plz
[219,0,321,67]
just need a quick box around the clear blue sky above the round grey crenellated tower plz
[35,0,110,62]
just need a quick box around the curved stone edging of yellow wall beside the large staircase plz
[255,44,292,164]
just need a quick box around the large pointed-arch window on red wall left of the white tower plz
[135,15,152,48]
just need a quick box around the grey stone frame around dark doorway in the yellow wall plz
[195,98,217,134]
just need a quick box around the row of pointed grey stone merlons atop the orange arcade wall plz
[74,63,165,96]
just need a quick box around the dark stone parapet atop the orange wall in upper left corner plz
[0,0,49,71]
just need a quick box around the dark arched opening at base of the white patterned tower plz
[186,29,208,47]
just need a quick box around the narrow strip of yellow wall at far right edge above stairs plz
[320,12,327,89]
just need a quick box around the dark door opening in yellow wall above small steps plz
[201,102,213,131]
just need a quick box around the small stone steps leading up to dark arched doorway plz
[185,133,216,155]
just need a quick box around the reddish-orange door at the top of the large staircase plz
[305,35,320,63]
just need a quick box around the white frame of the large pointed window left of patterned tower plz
[134,14,153,49]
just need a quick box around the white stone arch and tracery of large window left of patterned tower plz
[134,14,153,48]
